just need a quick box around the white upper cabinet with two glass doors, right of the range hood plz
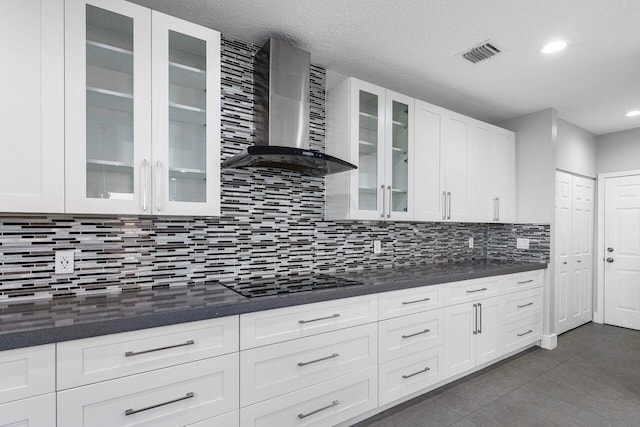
[326,78,414,220]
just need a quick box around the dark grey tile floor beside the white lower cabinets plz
[356,323,640,427]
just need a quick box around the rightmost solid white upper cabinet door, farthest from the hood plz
[491,126,516,223]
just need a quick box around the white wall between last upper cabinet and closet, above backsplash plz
[498,108,557,224]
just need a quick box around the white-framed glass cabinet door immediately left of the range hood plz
[152,12,220,215]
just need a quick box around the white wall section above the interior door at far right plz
[597,128,640,173]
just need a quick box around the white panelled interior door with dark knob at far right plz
[604,175,640,329]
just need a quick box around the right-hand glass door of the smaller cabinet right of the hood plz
[386,91,414,219]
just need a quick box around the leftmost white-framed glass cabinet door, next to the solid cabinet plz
[65,0,151,213]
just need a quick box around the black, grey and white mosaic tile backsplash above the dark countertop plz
[0,38,550,301]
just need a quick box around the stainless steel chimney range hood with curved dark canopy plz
[222,39,356,176]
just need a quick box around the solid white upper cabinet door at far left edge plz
[0,0,64,213]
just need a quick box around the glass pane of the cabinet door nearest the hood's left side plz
[168,31,207,203]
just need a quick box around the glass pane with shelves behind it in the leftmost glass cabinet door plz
[86,5,134,200]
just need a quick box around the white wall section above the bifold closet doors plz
[556,118,598,178]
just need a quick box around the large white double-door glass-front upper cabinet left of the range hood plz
[65,0,220,215]
